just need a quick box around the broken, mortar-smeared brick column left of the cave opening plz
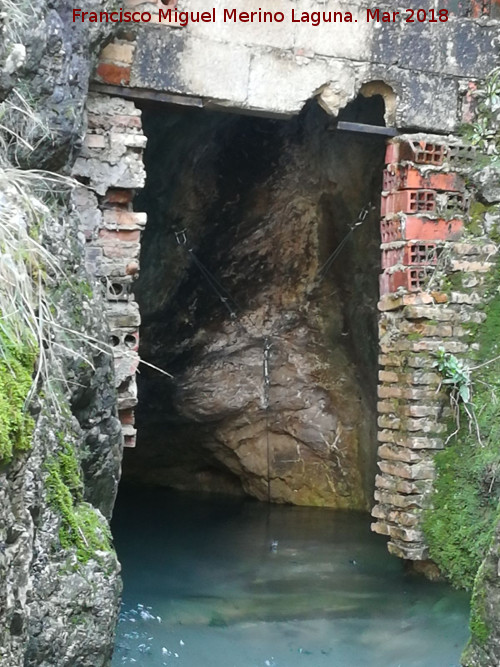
[73,94,146,447]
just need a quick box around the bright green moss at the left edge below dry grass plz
[0,329,36,463]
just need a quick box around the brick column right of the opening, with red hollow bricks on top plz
[372,135,497,560]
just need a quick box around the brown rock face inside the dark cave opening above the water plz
[124,99,384,509]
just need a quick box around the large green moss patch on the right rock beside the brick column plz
[424,283,500,588]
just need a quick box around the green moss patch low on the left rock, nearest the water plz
[46,443,111,563]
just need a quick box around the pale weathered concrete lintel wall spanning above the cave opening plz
[90,0,498,131]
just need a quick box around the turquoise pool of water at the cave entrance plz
[113,489,468,667]
